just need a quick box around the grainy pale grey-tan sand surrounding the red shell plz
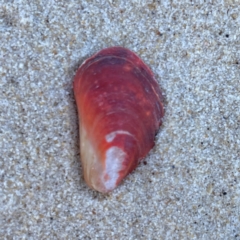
[0,0,240,240]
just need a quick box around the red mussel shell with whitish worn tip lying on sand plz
[73,47,164,193]
